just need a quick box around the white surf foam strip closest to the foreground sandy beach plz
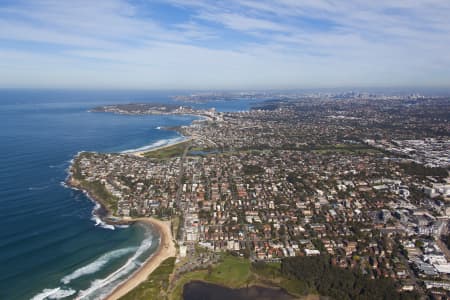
[77,236,153,299]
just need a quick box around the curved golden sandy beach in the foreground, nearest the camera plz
[105,218,177,300]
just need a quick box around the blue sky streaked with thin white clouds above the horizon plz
[0,0,450,90]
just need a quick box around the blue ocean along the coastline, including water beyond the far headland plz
[0,90,255,300]
